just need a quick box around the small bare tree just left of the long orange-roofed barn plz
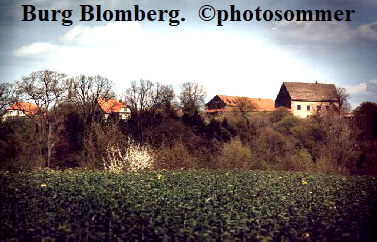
[179,82,207,115]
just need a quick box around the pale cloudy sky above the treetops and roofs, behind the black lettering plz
[0,0,377,108]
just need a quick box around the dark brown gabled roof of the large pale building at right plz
[283,82,337,102]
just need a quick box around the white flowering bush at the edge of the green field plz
[103,138,154,172]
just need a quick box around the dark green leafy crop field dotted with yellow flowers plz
[0,170,377,241]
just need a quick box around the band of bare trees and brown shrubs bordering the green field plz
[0,70,377,173]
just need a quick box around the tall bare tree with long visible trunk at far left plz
[16,70,67,167]
